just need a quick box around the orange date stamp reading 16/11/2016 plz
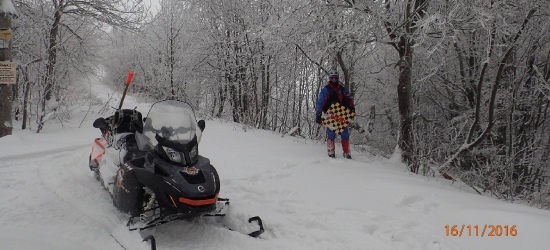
[445,224,518,237]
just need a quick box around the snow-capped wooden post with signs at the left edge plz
[0,3,16,137]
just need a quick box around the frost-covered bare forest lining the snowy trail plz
[1,0,550,209]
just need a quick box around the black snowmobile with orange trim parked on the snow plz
[89,100,264,248]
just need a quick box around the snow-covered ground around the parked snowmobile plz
[0,80,550,250]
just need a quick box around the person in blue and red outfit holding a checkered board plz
[315,70,355,159]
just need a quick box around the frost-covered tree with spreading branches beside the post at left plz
[16,0,149,132]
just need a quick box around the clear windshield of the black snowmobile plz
[143,100,201,146]
